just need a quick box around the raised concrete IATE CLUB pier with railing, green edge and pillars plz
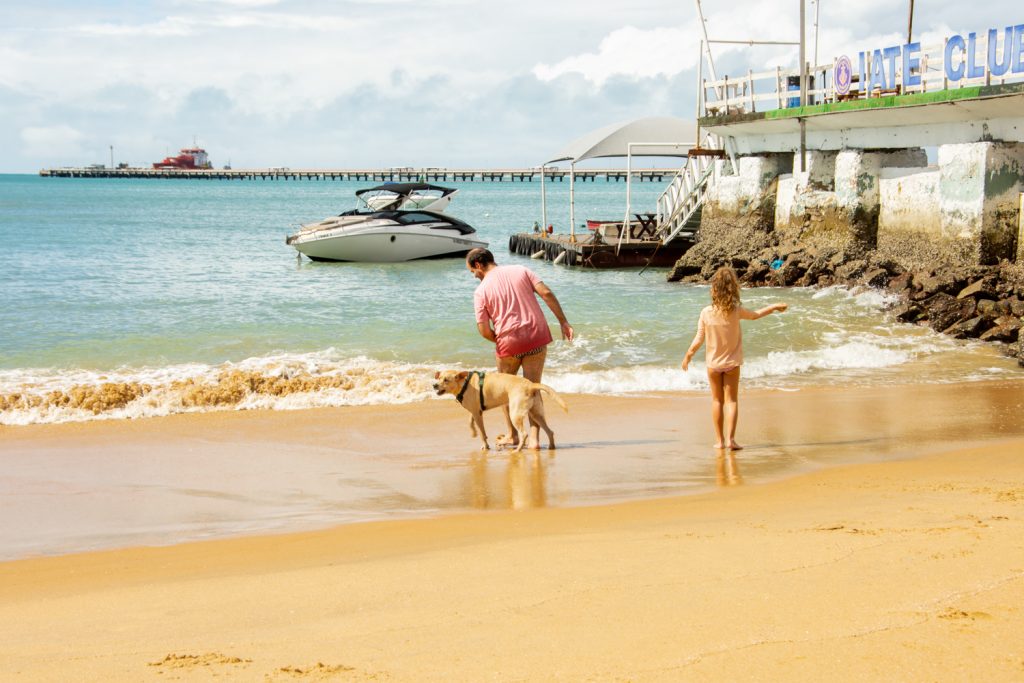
[697,20,1024,264]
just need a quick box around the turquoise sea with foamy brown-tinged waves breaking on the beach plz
[0,175,1020,424]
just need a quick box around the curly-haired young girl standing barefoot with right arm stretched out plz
[682,266,788,451]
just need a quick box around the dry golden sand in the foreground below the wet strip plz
[0,428,1024,681]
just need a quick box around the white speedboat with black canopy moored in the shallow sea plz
[285,182,487,263]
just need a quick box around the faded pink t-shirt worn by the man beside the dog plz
[473,265,551,357]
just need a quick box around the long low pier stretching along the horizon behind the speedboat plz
[39,166,677,182]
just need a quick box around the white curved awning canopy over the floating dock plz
[545,117,696,164]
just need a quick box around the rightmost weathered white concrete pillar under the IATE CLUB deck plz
[939,142,1024,263]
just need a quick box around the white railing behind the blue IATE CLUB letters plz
[701,32,1024,117]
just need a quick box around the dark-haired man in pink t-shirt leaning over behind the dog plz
[466,249,573,447]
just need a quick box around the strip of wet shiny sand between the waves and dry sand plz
[0,380,1024,561]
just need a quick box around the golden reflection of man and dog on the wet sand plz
[467,452,554,510]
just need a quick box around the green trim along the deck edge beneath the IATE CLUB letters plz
[700,83,1024,126]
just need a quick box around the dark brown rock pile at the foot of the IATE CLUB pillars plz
[669,227,1024,367]
